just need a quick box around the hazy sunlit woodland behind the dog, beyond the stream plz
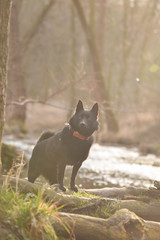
[5,0,160,154]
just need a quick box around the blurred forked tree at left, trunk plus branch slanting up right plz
[7,0,56,131]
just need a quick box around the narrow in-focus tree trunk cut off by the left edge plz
[0,0,12,180]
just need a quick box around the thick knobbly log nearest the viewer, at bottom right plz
[53,209,160,240]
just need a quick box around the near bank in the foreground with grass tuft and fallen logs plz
[0,176,160,240]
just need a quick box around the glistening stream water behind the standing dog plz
[3,136,160,188]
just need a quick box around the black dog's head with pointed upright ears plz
[69,100,98,137]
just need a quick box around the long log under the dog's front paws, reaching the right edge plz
[4,177,160,221]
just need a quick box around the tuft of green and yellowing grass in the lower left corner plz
[0,188,69,240]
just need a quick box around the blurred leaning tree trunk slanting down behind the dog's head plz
[72,0,118,132]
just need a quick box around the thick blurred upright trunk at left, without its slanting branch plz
[7,1,26,126]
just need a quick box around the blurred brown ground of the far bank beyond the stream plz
[5,103,160,156]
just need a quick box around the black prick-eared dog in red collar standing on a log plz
[28,100,98,192]
